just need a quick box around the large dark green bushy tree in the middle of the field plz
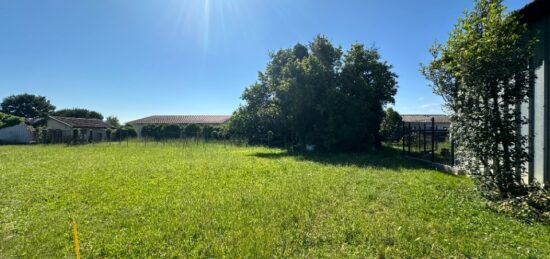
[230,36,397,151]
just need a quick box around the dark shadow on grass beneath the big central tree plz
[251,148,442,171]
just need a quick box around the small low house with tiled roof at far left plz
[46,116,114,143]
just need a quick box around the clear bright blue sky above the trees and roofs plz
[0,0,529,121]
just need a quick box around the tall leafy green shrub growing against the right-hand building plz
[423,0,532,198]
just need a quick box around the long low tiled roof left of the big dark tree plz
[128,115,231,124]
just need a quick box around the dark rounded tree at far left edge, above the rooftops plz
[0,94,55,118]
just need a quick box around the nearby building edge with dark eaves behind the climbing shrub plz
[519,0,550,187]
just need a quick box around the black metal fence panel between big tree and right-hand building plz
[401,118,457,166]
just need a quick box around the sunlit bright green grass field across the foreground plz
[0,142,550,258]
